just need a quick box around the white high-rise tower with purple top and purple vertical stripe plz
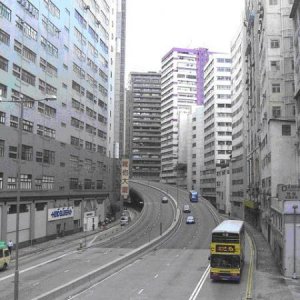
[161,48,209,187]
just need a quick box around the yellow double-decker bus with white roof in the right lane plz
[209,220,245,282]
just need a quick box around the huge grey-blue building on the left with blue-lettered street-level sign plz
[0,0,123,242]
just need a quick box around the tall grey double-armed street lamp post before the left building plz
[0,94,56,300]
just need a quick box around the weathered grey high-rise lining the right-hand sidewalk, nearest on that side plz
[245,0,299,276]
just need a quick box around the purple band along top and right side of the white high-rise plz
[162,48,210,105]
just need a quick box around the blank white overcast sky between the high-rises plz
[125,0,244,82]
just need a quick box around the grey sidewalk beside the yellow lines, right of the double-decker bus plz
[245,222,300,300]
